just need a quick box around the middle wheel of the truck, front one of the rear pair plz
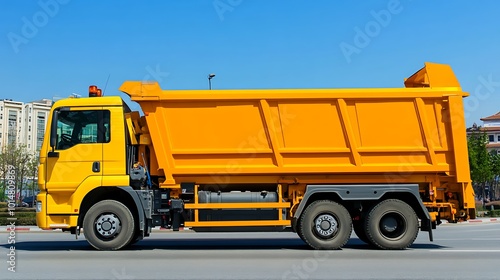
[299,200,352,250]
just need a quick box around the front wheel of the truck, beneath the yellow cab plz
[83,200,135,251]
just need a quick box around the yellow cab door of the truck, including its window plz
[46,107,109,214]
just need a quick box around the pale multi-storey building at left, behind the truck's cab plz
[0,99,52,152]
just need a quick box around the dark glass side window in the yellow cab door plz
[56,110,110,150]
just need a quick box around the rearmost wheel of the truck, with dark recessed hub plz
[365,199,418,250]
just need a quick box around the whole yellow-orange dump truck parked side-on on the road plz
[36,63,475,250]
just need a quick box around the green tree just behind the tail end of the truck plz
[467,127,494,206]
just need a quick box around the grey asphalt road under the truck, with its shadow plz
[0,223,500,280]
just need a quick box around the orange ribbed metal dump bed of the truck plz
[120,63,470,188]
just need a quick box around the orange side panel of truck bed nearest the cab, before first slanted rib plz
[162,101,271,151]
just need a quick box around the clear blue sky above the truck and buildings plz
[0,0,500,125]
